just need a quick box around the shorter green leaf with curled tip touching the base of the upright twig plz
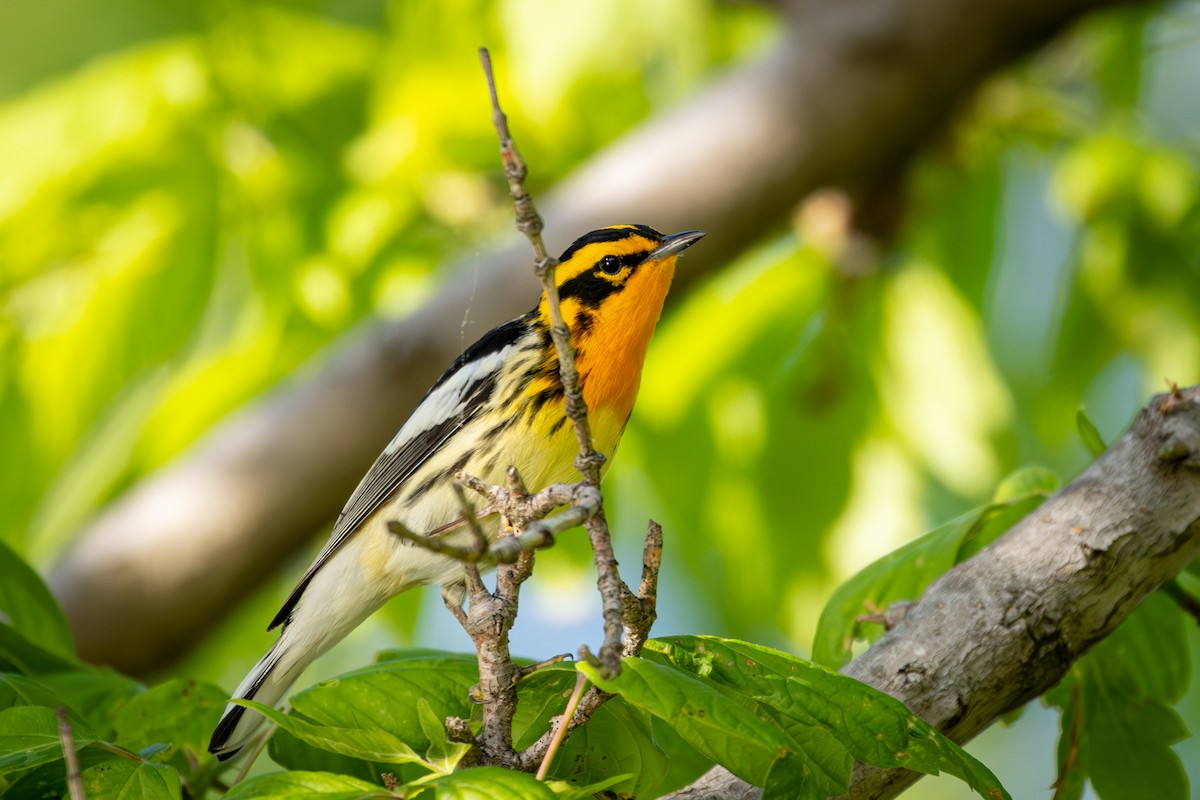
[577,658,796,786]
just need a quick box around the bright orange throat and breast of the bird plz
[563,257,676,429]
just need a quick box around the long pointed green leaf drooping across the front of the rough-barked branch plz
[647,636,1007,798]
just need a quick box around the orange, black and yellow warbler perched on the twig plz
[209,224,704,760]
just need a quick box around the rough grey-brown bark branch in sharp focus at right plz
[672,386,1200,800]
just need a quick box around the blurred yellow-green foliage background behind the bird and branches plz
[0,0,1200,798]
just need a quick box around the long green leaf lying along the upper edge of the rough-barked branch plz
[812,467,1058,668]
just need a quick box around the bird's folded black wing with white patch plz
[268,318,528,630]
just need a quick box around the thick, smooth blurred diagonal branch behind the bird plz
[50,0,1142,673]
